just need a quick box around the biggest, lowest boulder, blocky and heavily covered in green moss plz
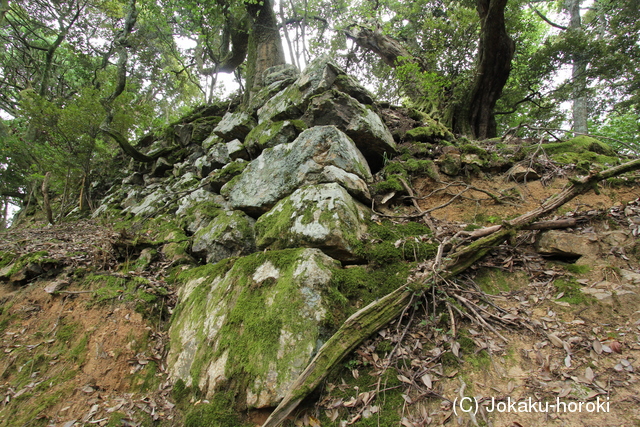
[168,249,336,408]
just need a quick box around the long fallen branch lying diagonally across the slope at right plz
[262,159,640,427]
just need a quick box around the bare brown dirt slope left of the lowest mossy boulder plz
[0,272,175,426]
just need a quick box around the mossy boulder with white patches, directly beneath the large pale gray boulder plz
[256,183,370,262]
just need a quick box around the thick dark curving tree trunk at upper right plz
[454,0,515,139]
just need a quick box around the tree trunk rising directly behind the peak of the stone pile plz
[246,0,286,98]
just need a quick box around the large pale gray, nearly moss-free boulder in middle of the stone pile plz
[226,126,372,216]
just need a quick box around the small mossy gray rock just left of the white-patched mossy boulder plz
[191,211,255,264]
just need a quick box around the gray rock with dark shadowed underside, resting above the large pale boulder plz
[302,90,396,170]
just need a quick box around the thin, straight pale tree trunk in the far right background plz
[565,0,589,133]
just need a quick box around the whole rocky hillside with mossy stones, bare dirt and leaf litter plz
[0,58,640,427]
